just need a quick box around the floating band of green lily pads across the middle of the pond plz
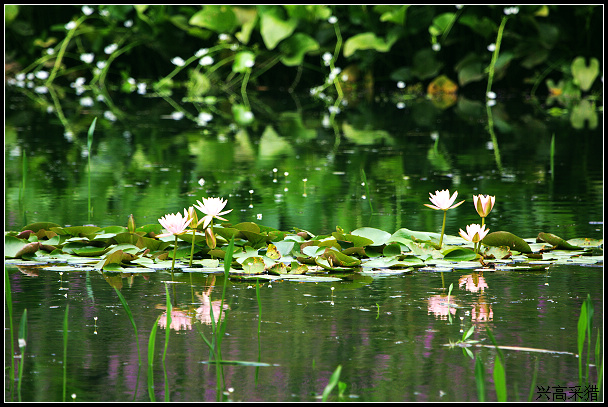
[5,217,603,281]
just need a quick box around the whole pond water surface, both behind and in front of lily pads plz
[5,84,603,402]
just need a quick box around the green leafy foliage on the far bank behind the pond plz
[5,5,603,102]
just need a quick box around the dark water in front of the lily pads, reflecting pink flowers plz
[4,266,603,401]
